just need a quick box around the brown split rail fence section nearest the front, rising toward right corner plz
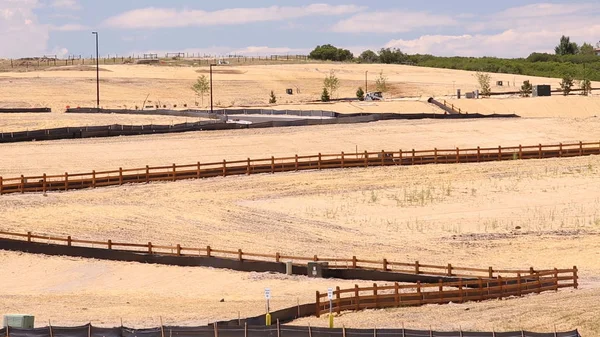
[316,267,578,317]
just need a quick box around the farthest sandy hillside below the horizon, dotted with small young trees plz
[0,64,599,112]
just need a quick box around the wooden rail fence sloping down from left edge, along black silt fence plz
[0,231,554,279]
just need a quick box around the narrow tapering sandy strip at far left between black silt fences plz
[0,113,207,133]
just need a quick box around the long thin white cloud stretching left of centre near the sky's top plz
[103,4,364,28]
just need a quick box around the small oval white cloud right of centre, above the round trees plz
[332,10,458,33]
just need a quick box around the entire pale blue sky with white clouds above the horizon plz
[0,0,600,57]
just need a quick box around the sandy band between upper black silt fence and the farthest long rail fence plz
[0,118,600,178]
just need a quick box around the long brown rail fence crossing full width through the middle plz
[0,142,600,195]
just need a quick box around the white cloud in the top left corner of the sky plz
[0,0,49,57]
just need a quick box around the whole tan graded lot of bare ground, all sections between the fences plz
[0,64,600,336]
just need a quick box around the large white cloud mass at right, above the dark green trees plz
[386,3,600,57]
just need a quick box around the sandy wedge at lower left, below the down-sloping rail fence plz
[0,252,354,328]
